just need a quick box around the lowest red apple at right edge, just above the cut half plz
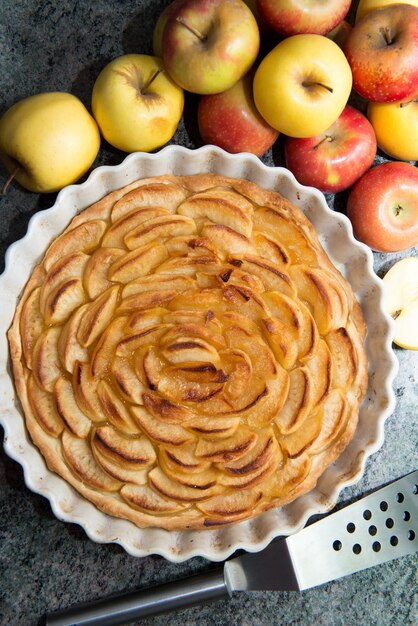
[347,161,418,252]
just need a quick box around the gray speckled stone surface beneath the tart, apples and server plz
[0,0,418,626]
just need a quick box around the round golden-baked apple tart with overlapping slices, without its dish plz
[9,174,367,530]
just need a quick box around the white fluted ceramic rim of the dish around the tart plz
[0,145,398,562]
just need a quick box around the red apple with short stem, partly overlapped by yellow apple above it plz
[285,105,376,193]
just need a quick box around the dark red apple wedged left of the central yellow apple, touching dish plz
[198,74,279,156]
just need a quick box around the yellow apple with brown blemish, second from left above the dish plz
[91,54,184,152]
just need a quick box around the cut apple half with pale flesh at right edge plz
[383,257,418,350]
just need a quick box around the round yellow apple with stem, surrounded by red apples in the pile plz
[253,35,352,137]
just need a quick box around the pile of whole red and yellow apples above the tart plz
[0,0,418,342]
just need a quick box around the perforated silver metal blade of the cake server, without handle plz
[286,470,418,590]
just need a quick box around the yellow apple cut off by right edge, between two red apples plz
[367,96,418,161]
